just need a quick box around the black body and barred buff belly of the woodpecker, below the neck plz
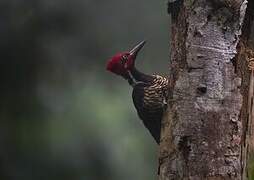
[132,75,168,143]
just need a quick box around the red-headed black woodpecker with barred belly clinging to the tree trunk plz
[107,41,168,144]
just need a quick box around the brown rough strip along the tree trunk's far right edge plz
[236,1,254,180]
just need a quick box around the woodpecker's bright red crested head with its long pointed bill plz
[107,41,146,78]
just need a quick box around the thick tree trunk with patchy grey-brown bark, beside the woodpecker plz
[159,0,254,180]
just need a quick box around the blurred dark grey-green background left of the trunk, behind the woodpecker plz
[0,0,169,180]
